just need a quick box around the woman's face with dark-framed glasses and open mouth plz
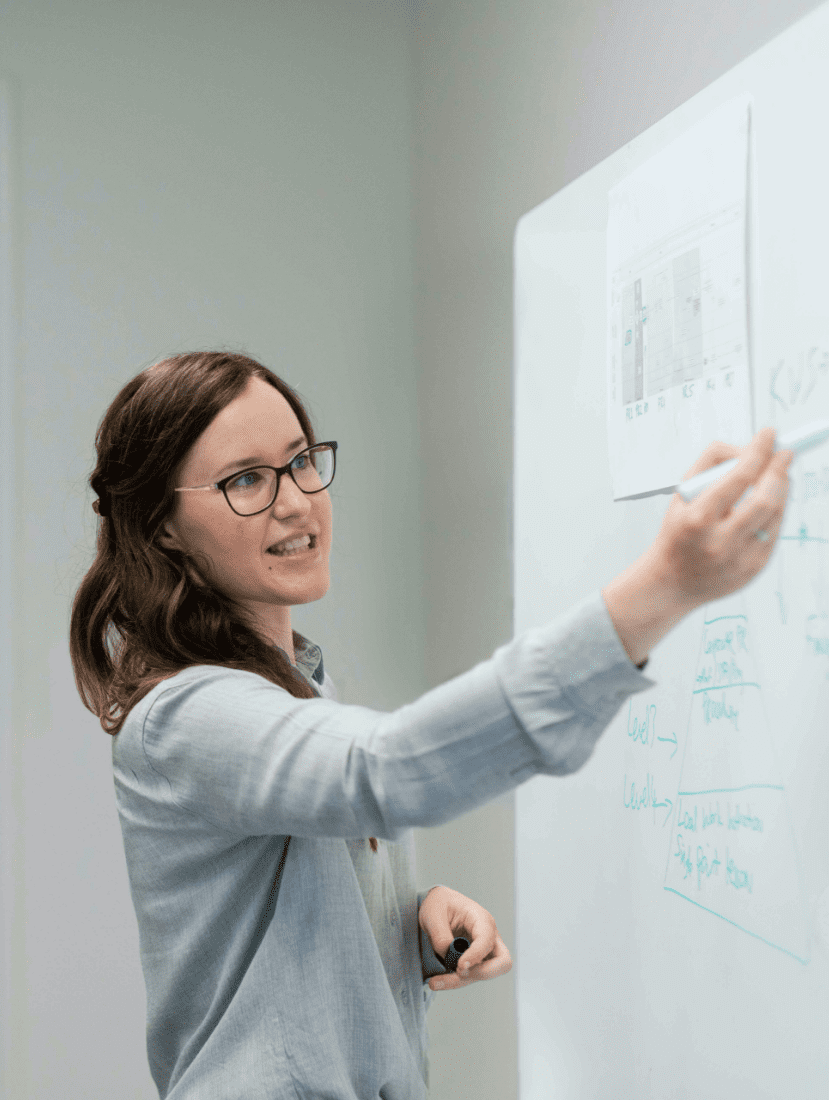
[159,378,331,652]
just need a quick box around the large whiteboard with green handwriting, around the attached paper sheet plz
[513,4,829,1100]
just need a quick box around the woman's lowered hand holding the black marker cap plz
[418,887,512,989]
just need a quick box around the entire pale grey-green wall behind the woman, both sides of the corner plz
[0,0,814,1100]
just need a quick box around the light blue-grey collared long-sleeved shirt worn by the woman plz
[112,592,653,1100]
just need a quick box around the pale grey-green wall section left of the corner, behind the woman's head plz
[0,0,423,1100]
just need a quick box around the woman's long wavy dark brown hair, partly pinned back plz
[69,352,317,736]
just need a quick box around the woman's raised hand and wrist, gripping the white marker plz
[601,428,794,664]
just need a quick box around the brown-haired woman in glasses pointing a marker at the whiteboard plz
[70,352,793,1100]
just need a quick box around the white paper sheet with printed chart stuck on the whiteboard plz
[607,97,752,499]
